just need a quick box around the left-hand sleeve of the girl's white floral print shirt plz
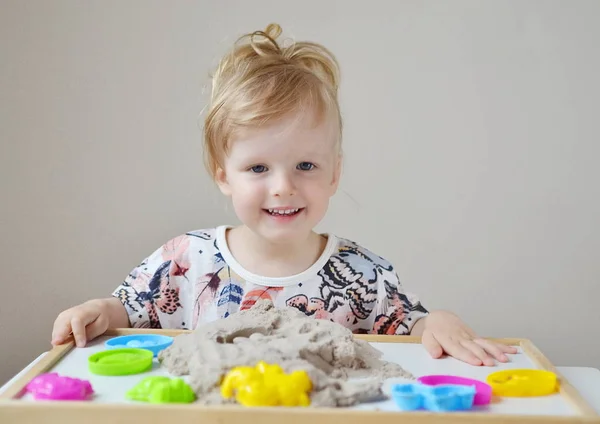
[112,239,187,329]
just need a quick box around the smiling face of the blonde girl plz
[216,114,341,243]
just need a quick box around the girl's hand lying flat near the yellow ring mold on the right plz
[421,311,517,366]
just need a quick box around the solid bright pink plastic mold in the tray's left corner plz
[25,373,94,400]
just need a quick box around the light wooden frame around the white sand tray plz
[0,328,600,424]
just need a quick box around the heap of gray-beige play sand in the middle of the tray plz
[159,300,414,407]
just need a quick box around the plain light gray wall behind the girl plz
[0,0,600,381]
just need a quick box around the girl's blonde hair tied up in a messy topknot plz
[204,24,342,178]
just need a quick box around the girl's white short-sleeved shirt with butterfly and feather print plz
[113,226,428,334]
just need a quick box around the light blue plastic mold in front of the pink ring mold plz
[392,383,475,411]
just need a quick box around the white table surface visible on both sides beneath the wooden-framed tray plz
[0,352,600,414]
